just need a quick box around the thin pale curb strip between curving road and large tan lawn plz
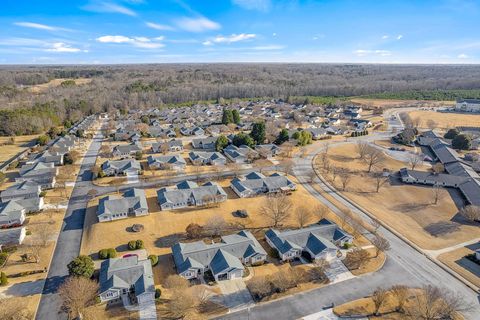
[312,155,479,293]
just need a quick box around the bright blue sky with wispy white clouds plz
[0,0,480,64]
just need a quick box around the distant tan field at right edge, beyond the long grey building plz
[408,110,480,130]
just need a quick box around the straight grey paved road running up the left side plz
[36,122,102,320]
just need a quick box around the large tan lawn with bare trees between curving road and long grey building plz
[316,144,478,250]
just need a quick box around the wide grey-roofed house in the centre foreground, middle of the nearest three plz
[172,231,267,281]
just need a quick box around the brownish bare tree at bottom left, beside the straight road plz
[58,277,98,319]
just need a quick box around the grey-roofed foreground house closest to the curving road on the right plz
[265,219,353,261]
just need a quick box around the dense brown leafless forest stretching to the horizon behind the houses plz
[0,64,480,135]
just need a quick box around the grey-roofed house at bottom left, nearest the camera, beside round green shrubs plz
[99,256,155,307]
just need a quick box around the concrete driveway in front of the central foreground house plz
[214,279,255,312]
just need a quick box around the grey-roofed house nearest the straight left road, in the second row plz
[97,188,148,222]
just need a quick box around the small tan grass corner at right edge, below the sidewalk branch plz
[438,245,480,287]
